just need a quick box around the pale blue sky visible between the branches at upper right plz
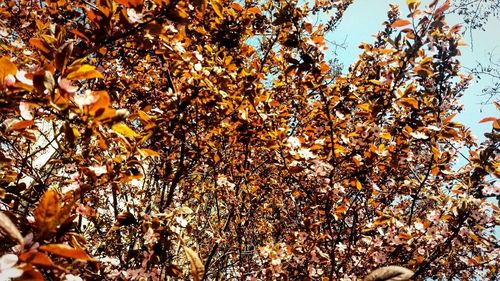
[327,0,500,141]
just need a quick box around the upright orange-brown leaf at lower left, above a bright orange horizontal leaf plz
[34,189,61,234]
